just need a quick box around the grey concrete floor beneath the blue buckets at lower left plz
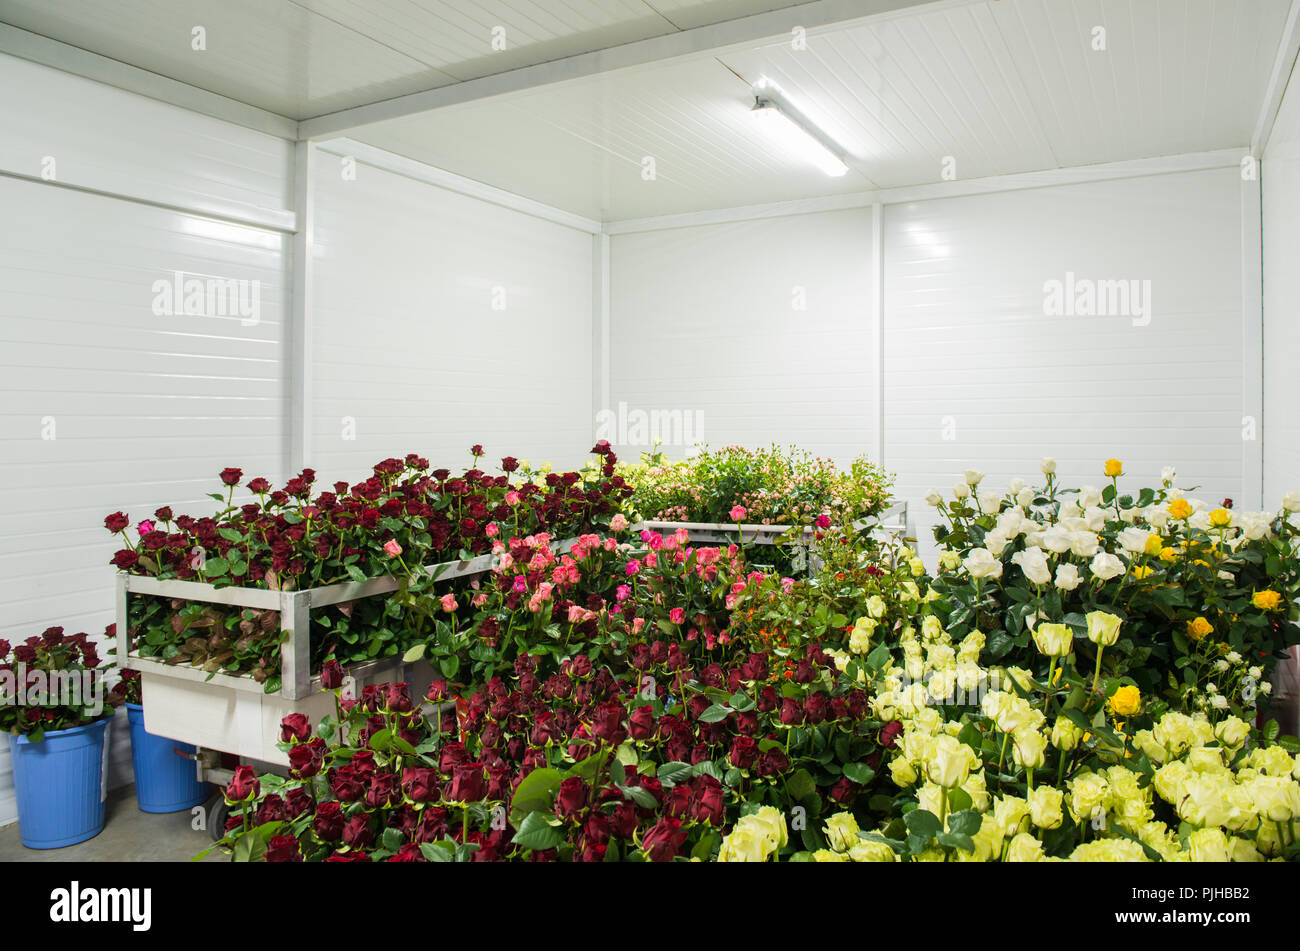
[0,786,226,861]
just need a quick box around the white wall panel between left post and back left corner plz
[311,153,593,481]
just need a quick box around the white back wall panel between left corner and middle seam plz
[610,208,876,464]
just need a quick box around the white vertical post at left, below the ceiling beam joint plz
[285,142,319,474]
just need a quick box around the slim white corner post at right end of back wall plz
[1239,170,1263,511]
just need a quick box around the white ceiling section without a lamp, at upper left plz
[0,0,806,120]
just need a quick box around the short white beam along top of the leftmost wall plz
[0,23,298,139]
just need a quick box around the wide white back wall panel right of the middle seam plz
[884,169,1243,561]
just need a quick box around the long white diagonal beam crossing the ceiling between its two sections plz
[298,0,967,139]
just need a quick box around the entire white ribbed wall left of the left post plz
[0,56,291,822]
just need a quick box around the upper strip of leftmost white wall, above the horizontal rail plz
[0,53,293,226]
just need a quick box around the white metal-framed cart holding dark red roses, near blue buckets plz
[116,539,577,783]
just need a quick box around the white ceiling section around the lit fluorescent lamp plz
[352,0,1290,220]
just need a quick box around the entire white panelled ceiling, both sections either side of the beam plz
[0,0,1291,221]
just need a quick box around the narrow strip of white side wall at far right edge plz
[1261,78,1300,508]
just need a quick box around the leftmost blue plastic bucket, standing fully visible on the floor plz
[9,718,109,848]
